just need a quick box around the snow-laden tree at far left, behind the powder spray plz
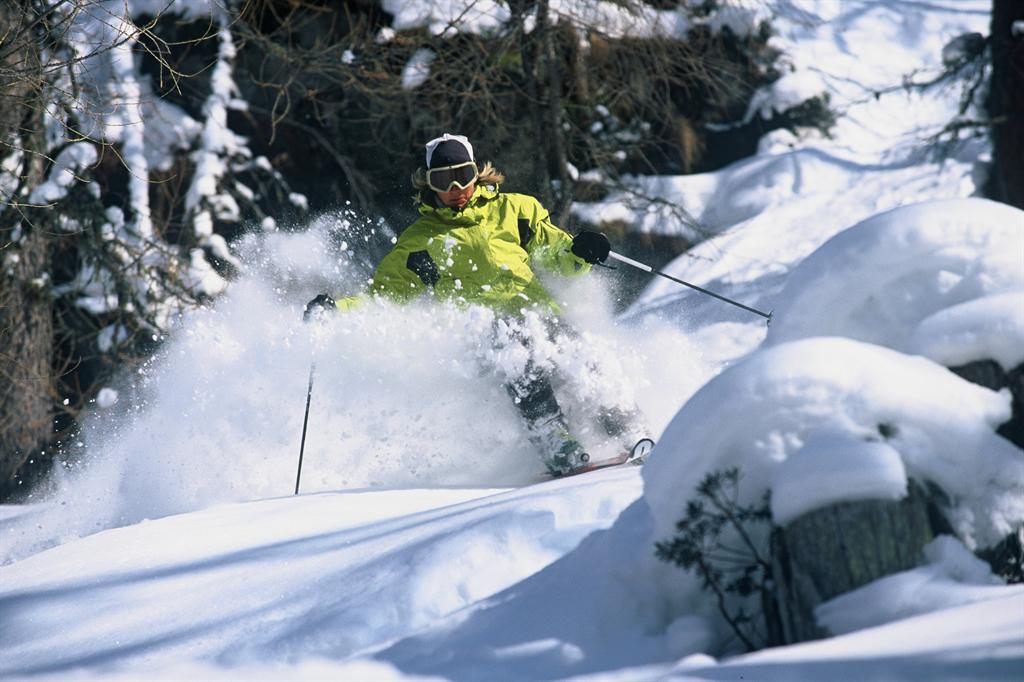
[0,0,264,499]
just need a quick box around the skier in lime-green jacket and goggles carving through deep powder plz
[305,133,640,476]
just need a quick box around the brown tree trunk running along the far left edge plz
[0,3,53,500]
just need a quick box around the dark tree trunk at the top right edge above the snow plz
[987,0,1024,209]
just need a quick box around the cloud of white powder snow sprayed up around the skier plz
[0,210,712,561]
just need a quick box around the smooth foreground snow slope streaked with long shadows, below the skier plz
[0,469,639,677]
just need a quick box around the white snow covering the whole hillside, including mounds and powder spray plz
[0,0,1024,680]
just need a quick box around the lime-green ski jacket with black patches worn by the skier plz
[337,185,590,314]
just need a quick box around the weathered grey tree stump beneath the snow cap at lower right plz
[766,482,936,645]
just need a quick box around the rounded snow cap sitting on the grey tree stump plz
[643,338,1024,546]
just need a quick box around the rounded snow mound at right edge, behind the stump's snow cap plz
[766,199,1024,364]
